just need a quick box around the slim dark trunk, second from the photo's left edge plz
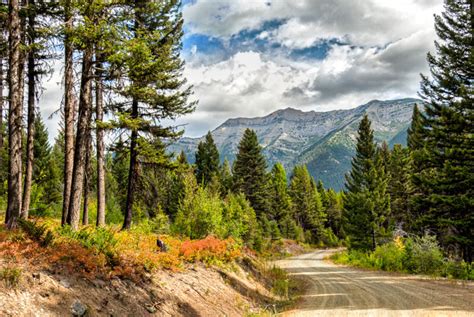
[21,0,36,219]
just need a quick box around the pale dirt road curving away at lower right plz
[277,250,474,317]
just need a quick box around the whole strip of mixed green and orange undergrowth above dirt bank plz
[0,220,241,280]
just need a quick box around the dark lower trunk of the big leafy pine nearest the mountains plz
[122,99,138,230]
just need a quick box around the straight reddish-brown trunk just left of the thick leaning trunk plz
[61,0,76,225]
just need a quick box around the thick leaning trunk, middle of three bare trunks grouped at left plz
[67,46,93,230]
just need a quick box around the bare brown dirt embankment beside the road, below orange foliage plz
[0,258,274,316]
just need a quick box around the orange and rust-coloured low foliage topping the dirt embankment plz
[0,222,241,281]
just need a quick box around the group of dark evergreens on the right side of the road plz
[344,0,474,263]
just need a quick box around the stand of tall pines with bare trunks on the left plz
[0,0,195,230]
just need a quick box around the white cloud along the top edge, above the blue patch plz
[184,0,442,48]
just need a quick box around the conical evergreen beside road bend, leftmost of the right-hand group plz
[344,115,390,249]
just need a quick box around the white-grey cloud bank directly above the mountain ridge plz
[179,22,433,136]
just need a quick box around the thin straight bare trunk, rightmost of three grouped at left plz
[96,57,105,227]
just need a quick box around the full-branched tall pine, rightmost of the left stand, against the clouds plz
[109,0,195,230]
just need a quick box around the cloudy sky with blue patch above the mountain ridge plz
[39,0,442,137]
